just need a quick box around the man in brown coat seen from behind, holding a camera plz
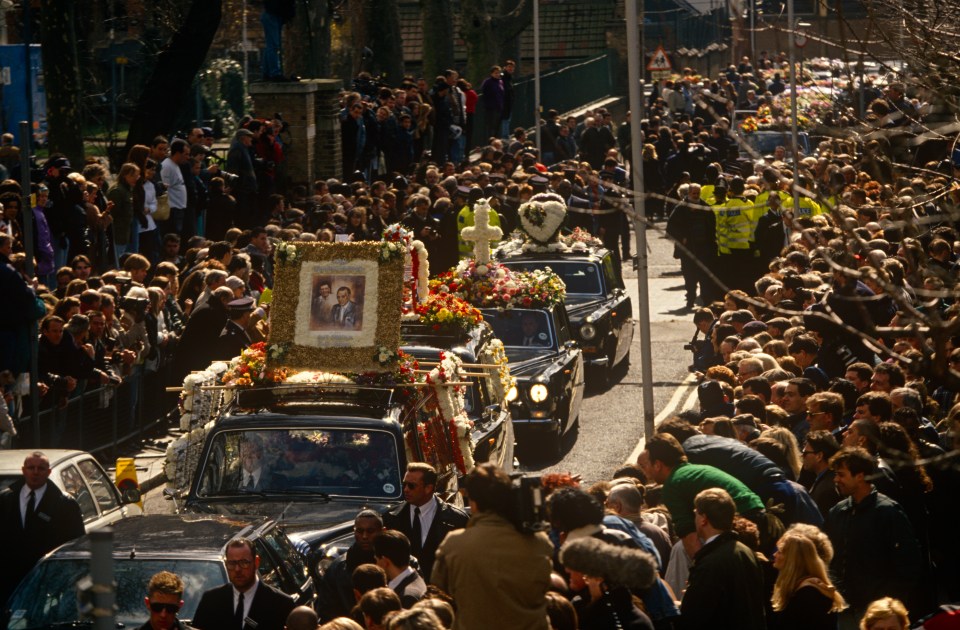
[432,462,553,630]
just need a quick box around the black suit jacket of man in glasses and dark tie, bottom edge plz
[190,580,296,630]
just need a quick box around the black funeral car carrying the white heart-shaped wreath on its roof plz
[499,248,634,385]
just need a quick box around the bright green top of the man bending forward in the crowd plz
[663,464,763,538]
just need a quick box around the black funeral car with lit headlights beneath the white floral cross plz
[480,304,584,457]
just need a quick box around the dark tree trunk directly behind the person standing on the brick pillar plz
[283,2,330,79]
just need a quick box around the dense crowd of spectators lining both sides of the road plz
[0,48,960,630]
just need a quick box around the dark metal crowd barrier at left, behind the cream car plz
[13,366,176,458]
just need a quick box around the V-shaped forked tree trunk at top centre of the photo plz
[460,0,537,84]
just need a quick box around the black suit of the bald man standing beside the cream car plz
[0,477,85,604]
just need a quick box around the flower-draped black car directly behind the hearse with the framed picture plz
[400,322,514,472]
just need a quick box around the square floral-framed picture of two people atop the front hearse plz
[267,242,403,372]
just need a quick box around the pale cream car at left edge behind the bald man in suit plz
[0,449,143,532]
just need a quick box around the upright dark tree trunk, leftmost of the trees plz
[40,0,84,168]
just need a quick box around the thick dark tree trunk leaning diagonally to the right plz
[122,0,223,155]
